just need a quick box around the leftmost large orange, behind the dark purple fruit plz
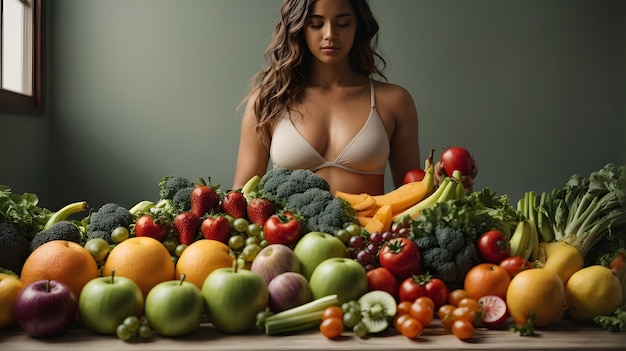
[20,240,99,298]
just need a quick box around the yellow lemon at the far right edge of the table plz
[565,265,622,322]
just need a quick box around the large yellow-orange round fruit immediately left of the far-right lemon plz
[506,268,565,327]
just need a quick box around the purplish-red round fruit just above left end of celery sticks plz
[267,272,313,313]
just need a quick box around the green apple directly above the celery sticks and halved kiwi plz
[309,257,367,303]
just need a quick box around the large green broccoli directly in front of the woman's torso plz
[257,167,358,234]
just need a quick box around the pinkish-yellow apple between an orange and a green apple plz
[250,244,300,284]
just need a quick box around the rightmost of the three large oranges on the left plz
[176,239,235,290]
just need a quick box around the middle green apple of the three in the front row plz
[145,275,205,336]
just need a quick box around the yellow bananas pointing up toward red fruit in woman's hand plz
[392,171,465,222]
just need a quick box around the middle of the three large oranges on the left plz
[102,236,174,297]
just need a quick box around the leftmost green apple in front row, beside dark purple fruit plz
[78,275,144,334]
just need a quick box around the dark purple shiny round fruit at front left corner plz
[15,280,78,338]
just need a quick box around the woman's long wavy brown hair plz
[244,0,387,143]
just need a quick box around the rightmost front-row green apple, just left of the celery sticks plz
[202,264,269,333]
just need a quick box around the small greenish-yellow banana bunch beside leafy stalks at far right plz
[509,191,554,262]
